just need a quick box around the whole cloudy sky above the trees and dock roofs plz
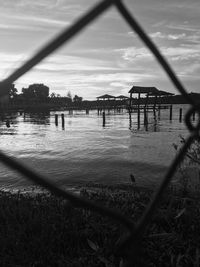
[0,0,200,100]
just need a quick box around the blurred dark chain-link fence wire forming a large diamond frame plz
[0,0,200,266]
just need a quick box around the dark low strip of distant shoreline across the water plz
[0,93,200,112]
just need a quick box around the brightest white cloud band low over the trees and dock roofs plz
[16,70,155,99]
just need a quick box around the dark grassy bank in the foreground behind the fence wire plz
[0,185,200,267]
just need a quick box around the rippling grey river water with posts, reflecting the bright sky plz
[0,105,189,191]
